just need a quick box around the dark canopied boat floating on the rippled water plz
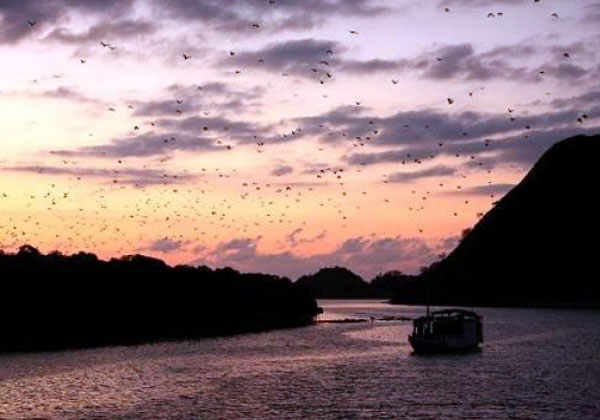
[408,307,483,354]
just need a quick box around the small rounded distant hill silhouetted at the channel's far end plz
[296,267,369,299]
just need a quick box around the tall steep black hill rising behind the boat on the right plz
[395,135,600,306]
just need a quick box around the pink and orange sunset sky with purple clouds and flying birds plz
[0,0,600,278]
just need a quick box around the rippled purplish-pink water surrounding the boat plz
[0,301,600,420]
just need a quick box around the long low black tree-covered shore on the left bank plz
[0,246,320,351]
